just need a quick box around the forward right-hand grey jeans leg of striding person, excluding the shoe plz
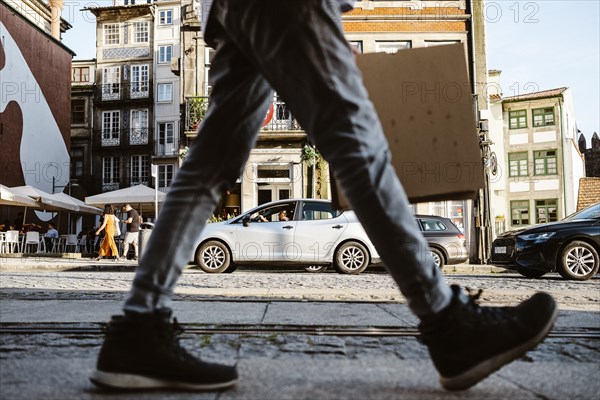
[213,0,452,317]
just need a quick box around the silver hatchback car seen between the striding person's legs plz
[194,199,381,274]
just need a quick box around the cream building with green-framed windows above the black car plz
[490,84,584,234]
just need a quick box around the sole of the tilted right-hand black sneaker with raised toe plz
[440,304,558,390]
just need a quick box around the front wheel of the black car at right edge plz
[558,240,600,281]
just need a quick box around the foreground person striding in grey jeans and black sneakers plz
[91,0,557,390]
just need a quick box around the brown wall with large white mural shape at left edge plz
[0,4,72,221]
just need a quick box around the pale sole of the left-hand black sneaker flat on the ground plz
[90,370,237,390]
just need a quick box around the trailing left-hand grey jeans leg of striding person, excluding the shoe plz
[124,40,271,313]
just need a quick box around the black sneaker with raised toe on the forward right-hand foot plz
[419,286,558,390]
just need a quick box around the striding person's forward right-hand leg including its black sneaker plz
[215,0,557,390]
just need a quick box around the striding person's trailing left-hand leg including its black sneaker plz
[90,15,271,390]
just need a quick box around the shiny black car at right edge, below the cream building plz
[491,203,600,281]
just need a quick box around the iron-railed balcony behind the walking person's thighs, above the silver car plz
[185,96,303,133]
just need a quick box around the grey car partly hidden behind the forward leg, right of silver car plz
[415,215,469,268]
